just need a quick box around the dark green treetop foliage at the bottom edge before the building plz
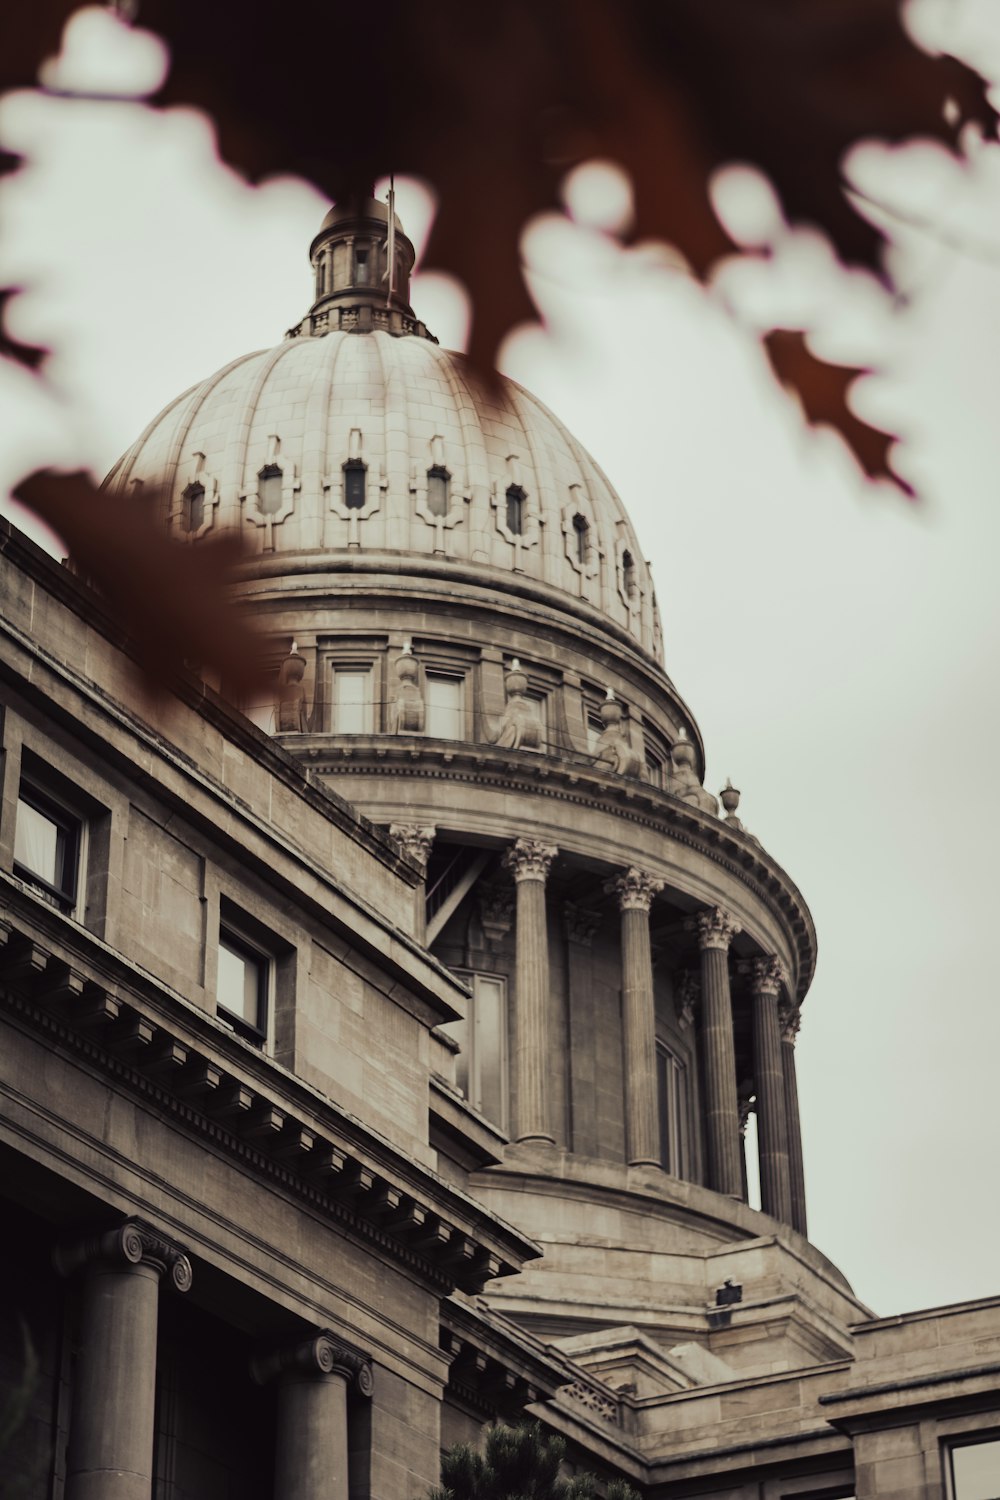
[427,1422,639,1500]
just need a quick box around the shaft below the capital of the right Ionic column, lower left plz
[274,1371,348,1500]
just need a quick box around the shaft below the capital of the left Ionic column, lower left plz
[66,1263,160,1500]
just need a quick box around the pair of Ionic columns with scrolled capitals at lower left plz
[52,1220,373,1500]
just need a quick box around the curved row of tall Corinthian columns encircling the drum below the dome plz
[393,827,807,1233]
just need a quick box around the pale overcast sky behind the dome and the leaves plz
[0,0,1000,1314]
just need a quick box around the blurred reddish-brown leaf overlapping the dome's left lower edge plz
[13,470,261,695]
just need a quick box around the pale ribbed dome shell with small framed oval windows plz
[108,328,661,660]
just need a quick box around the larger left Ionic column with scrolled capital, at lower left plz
[52,1220,190,1500]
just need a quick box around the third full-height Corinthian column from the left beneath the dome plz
[696,906,742,1199]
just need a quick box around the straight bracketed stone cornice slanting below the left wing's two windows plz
[0,897,538,1292]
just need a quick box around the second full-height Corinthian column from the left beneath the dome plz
[607,867,663,1167]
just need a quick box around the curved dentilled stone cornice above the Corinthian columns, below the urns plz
[295,735,817,1004]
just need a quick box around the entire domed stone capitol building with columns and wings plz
[0,200,1000,1500]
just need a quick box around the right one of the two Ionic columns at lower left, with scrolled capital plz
[250,1331,375,1500]
